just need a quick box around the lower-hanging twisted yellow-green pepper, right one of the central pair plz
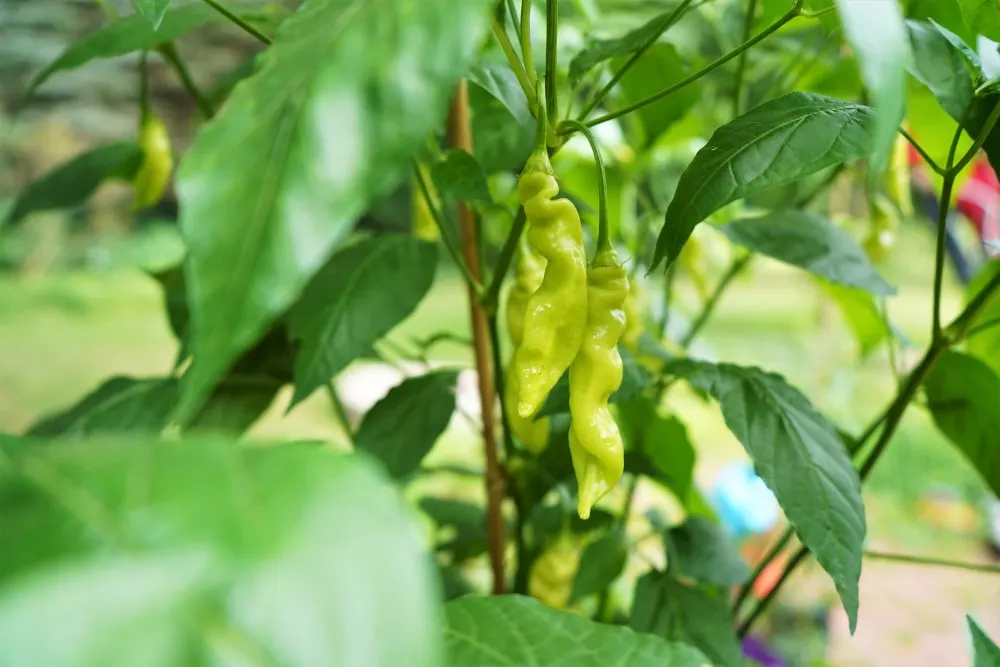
[569,246,629,519]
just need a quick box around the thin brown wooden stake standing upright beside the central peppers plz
[448,79,506,595]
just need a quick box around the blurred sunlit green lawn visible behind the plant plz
[0,222,983,552]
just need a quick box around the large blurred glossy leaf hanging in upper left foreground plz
[177,0,490,422]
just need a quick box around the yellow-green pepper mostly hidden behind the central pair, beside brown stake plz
[504,235,549,454]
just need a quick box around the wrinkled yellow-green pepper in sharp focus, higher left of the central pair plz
[514,146,587,419]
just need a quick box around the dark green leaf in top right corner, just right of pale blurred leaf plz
[906,21,973,120]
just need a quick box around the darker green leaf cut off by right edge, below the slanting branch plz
[924,351,1000,495]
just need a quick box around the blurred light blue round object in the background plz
[710,461,779,539]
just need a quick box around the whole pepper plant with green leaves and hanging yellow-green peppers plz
[0,0,1000,667]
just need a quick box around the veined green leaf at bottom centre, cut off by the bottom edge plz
[444,595,706,667]
